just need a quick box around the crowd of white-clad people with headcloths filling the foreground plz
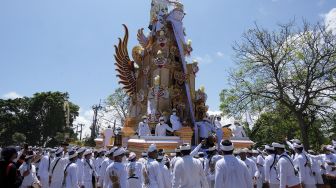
[0,137,336,188]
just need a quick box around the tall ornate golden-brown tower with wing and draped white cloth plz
[115,0,208,150]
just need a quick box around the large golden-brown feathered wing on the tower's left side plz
[114,24,136,96]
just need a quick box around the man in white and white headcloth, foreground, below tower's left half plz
[142,144,164,188]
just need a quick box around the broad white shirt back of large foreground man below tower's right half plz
[172,155,209,188]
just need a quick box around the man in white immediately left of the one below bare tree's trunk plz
[272,143,302,188]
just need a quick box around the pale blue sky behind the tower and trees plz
[0,0,336,129]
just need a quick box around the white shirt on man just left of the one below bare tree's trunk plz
[278,153,300,188]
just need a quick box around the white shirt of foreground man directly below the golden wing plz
[103,162,128,188]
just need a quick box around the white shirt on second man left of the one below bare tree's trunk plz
[264,154,280,184]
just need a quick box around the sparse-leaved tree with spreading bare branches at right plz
[221,22,336,149]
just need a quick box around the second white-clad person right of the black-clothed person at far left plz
[37,152,52,188]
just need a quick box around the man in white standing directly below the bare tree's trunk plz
[293,143,316,188]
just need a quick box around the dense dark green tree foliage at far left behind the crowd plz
[0,92,79,145]
